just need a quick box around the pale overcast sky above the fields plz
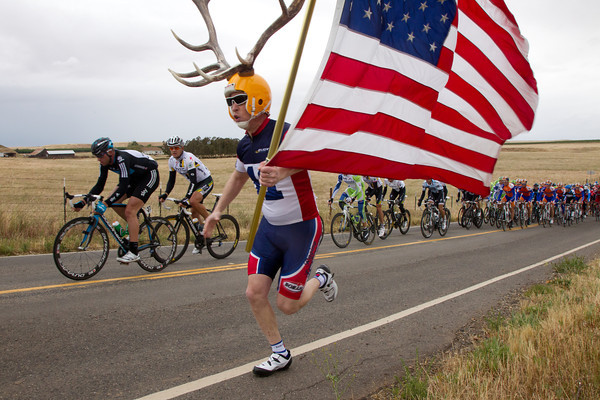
[0,0,600,148]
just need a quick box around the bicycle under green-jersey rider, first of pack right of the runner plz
[331,204,375,248]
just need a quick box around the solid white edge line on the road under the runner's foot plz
[138,239,600,400]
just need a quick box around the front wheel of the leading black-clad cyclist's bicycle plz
[52,217,109,281]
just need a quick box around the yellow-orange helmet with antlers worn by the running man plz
[225,73,271,118]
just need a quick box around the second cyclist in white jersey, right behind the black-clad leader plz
[158,136,213,250]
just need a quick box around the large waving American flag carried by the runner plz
[271,0,538,194]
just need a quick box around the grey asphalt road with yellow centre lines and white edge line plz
[0,219,600,400]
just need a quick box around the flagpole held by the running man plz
[246,0,316,253]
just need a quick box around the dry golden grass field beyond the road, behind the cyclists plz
[0,142,600,255]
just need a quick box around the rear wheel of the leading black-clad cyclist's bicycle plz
[138,217,177,272]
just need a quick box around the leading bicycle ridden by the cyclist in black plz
[52,193,177,280]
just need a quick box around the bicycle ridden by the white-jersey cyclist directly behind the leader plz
[163,193,240,263]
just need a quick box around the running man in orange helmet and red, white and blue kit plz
[204,73,338,376]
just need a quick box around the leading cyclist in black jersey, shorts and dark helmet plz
[73,137,159,263]
